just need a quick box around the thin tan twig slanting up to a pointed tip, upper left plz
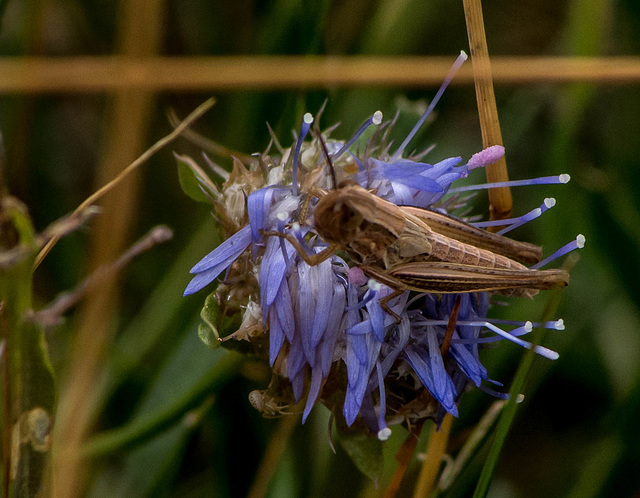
[34,98,215,269]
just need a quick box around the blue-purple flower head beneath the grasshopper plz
[185,70,583,439]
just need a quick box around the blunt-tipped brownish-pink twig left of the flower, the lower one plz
[29,225,173,326]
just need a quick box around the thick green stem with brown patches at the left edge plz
[0,198,56,496]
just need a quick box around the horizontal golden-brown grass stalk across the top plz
[0,53,640,94]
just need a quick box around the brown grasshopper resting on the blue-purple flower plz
[265,181,569,318]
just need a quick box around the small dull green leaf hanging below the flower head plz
[336,416,384,482]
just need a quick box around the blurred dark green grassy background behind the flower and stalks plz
[0,0,640,497]
